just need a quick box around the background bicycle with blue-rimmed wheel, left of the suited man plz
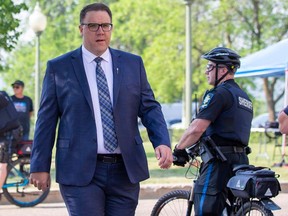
[2,135,50,207]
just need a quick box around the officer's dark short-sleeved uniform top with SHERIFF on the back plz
[196,79,253,146]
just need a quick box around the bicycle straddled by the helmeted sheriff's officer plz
[151,143,280,216]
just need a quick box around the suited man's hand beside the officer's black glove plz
[155,145,173,169]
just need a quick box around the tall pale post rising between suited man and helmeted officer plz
[184,0,192,127]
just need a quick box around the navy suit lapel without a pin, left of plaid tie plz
[71,47,94,117]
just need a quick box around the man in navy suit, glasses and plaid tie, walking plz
[30,3,172,216]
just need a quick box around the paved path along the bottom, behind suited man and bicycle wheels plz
[0,193,288,216]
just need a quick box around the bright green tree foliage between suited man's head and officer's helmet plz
[111,0,219,102]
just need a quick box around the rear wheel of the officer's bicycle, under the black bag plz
[236,201,273,216]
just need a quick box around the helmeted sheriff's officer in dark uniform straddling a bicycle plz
[173,47,253,216]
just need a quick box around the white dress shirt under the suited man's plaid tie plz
[82,45,120,154]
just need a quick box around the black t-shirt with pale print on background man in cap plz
[11,95,33,134]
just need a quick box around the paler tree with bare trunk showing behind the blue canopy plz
[217,0,288,121]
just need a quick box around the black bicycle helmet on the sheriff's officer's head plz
[201,47,241,71]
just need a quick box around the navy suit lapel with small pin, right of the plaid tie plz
[109,48,124,109]
